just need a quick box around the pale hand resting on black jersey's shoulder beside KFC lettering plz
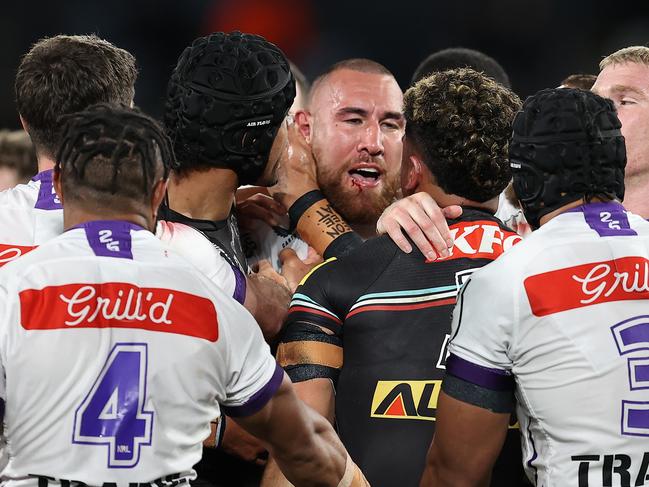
[376,192,462,260]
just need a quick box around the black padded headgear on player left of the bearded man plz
[164,31,295,184]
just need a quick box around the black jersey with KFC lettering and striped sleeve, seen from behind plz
[277,208,528,487]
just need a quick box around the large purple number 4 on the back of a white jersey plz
[72,343,153,468]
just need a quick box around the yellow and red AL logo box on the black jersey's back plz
[371,380,442,421]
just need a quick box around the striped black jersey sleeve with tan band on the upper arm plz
[277,259,344,382]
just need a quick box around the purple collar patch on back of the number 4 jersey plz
[70,220,144,259]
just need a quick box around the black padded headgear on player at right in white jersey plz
[509,88,626,228]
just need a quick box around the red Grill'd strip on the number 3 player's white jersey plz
[524,257,649,316]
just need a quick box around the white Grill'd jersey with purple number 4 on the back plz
[0,221,283,486]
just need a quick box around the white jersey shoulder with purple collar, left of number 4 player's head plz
[0,170,63,267]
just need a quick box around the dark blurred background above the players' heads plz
[0,0,649,128]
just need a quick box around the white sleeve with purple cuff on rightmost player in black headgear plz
[443,264,516,412]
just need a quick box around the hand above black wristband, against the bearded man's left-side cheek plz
[268,123,318,208]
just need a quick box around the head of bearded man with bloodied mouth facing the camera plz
[297,69,405,237]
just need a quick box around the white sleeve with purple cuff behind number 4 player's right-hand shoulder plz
[156,221,246,304]
